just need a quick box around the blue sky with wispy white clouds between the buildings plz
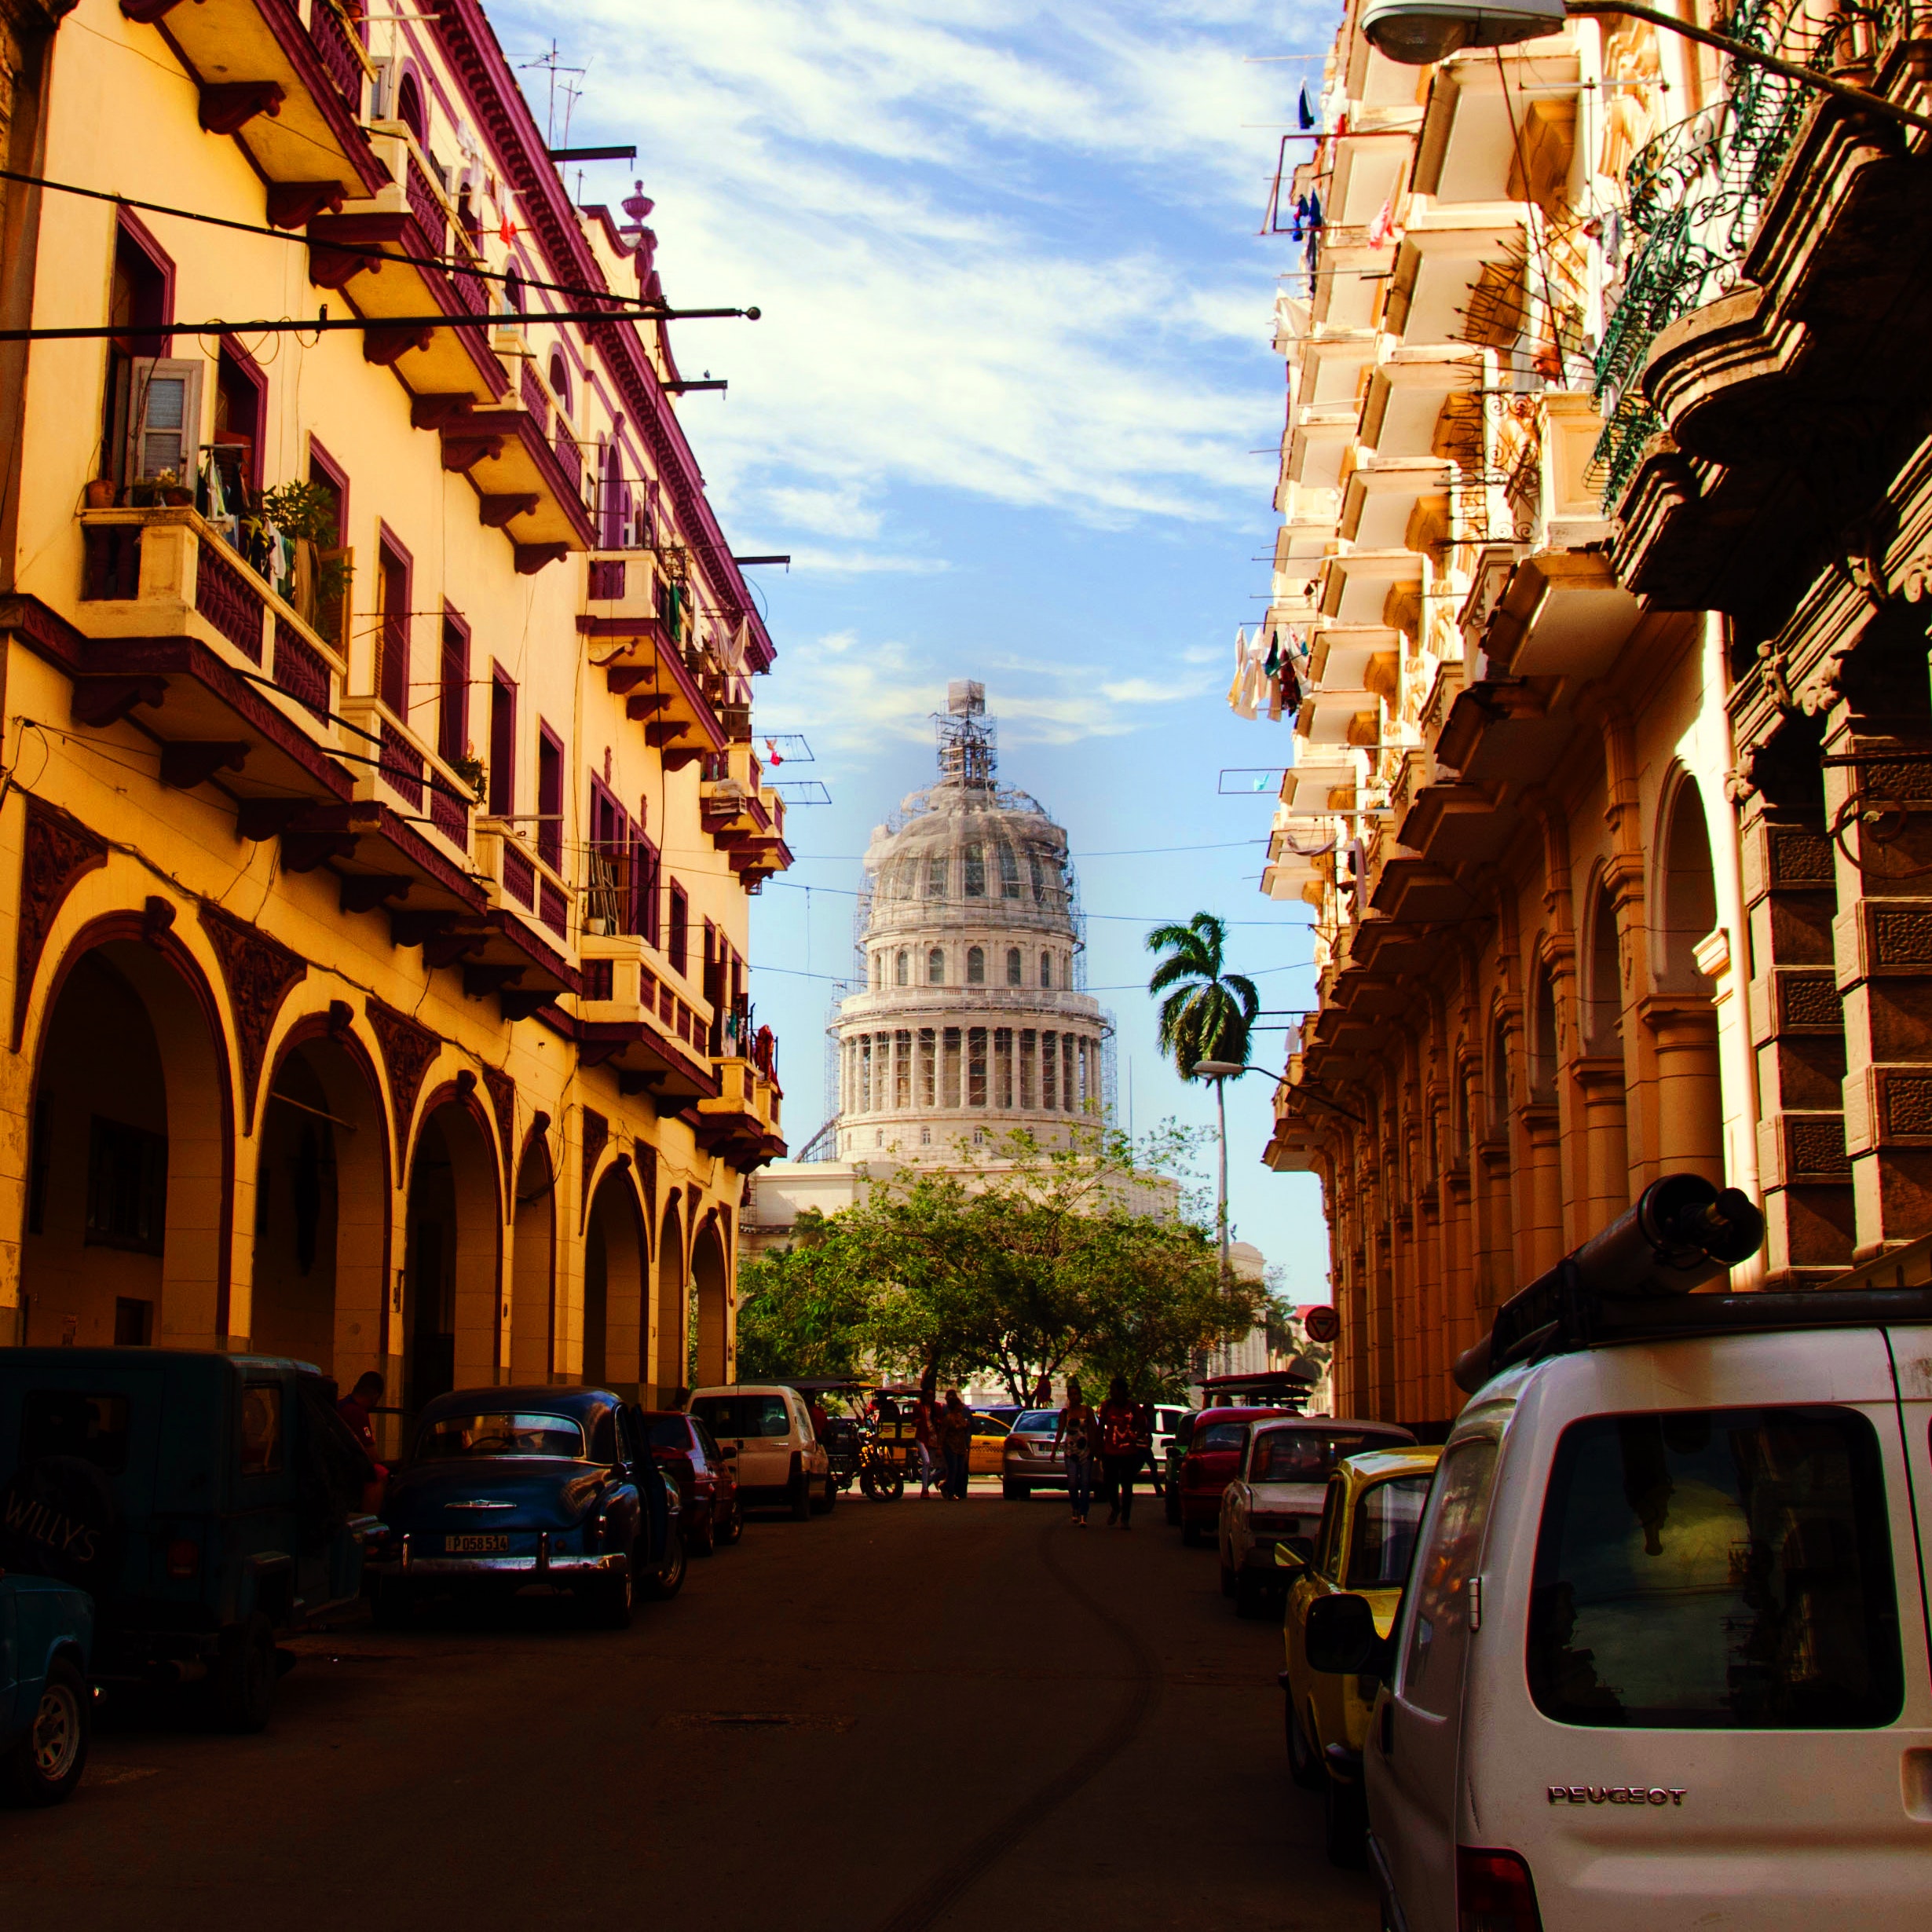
[492,0,1333,1301]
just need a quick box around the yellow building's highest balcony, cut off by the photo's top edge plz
[122,0,382,211]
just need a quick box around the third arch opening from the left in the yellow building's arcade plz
[400,1080,503,1412]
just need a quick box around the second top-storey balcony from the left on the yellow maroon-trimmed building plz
[309,124,510,404]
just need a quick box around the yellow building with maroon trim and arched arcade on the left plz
[0,0,789,1437]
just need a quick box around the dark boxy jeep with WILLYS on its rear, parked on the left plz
[0,1348,377,1731]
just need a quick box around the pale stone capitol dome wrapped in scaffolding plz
[832,682,1113,1161]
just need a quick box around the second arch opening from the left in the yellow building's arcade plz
[249,1003,400,1397]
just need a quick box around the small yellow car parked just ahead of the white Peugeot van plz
[1275,1449,1441,1864]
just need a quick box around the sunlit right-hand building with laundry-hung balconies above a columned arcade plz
[1231,5,1932,1425]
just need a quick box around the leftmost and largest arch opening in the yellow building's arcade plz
[21,916,236,1348]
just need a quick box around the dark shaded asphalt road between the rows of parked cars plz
[0,1490,1378,1932]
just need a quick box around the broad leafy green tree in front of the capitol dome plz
[738,1126,1265,1403]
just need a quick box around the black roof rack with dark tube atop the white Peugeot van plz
[1454,1175,1769,1395]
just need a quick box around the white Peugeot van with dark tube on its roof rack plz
[1308,1176,1932,1932]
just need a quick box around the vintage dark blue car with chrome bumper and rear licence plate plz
[369,1387,684,1629]
